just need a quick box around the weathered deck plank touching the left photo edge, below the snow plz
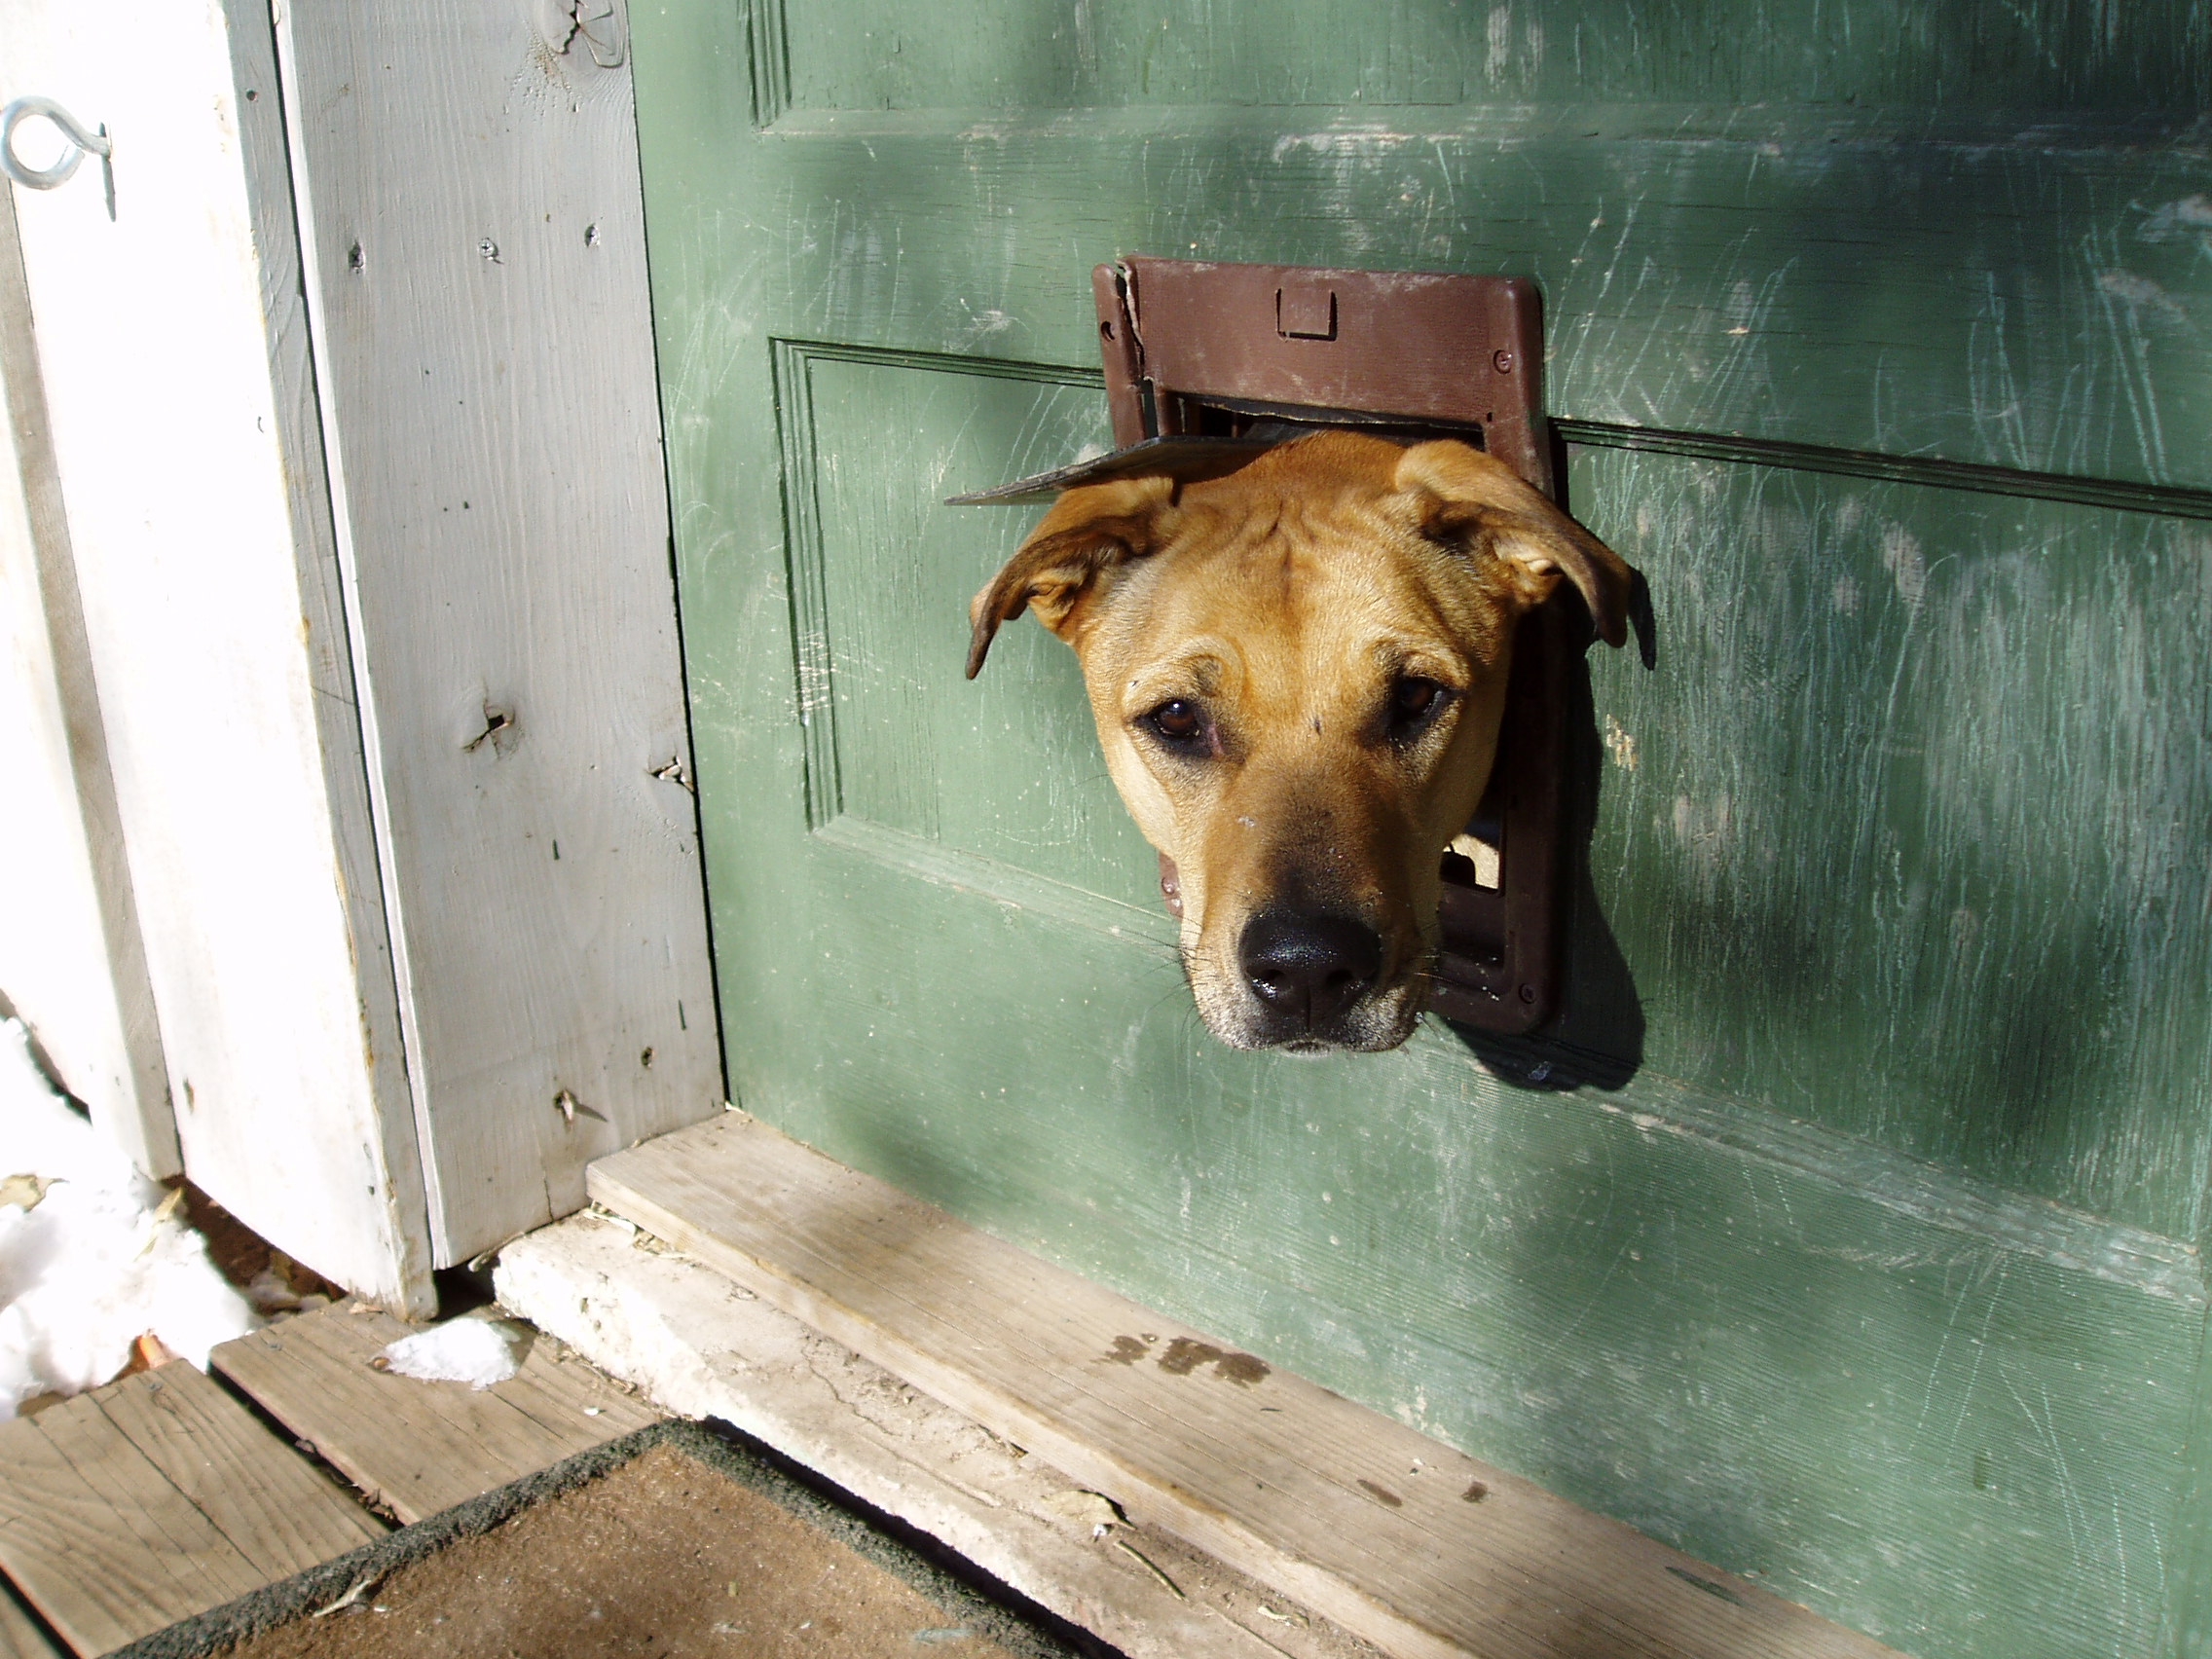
[0,1396,268,1654]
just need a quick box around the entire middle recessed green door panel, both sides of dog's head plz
[779,345,2212,1236]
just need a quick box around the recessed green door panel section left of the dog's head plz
[776,345,1160,911]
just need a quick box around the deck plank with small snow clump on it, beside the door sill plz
[214,1308,659,1522]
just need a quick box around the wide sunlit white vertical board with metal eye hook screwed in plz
[0,0,429,1305]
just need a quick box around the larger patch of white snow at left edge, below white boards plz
[0,1019,261,1418]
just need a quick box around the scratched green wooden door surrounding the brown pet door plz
[635,0,2212,1659]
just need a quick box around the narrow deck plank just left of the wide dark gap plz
[91,1365,385,1584]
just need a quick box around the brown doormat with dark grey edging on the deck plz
[115,1422,1117,1659]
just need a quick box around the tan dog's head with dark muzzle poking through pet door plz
[969,431,1633,1052]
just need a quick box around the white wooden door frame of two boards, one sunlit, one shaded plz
[0,0,723,1311]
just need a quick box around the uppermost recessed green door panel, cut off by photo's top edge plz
[755,0,2212,115]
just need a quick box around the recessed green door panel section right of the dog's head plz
[1570,451,2212,1238]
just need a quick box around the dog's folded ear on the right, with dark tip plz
[1396,438,1637,645]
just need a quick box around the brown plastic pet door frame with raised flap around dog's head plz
[956,259,1588,1033]
